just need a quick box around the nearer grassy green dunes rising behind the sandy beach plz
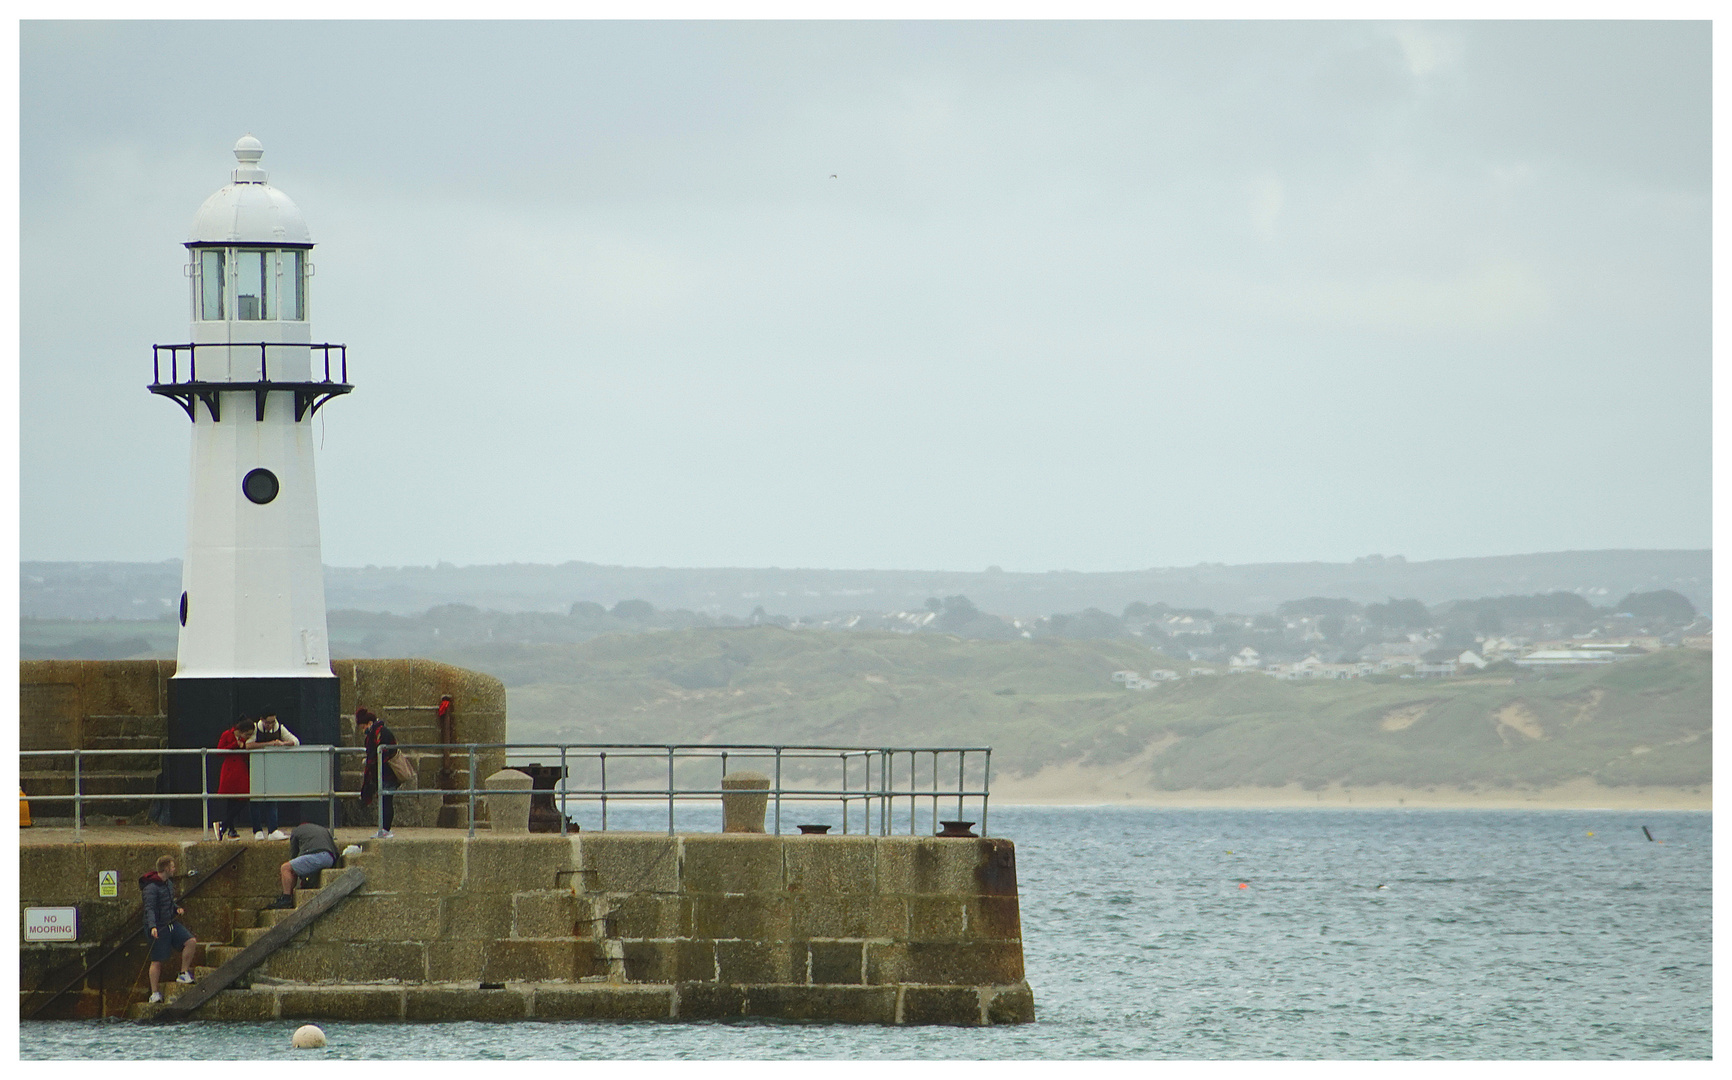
[442,627,1711,791]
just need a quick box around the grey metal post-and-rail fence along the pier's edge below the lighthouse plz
[19,743,992,836]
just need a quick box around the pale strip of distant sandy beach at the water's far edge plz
[992,765,1713,810]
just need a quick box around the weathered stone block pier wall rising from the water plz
[19,829,1034,1025]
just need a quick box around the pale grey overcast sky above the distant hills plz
[19,23,1711,571]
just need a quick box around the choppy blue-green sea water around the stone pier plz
[19,807,1711,1063]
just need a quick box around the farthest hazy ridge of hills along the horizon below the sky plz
[19,550,1713,620]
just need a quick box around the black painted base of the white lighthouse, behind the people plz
[158,675,341,829]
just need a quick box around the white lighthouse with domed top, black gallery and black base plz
[149,135,352,824]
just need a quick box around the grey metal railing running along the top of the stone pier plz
[19,743,992,838]
